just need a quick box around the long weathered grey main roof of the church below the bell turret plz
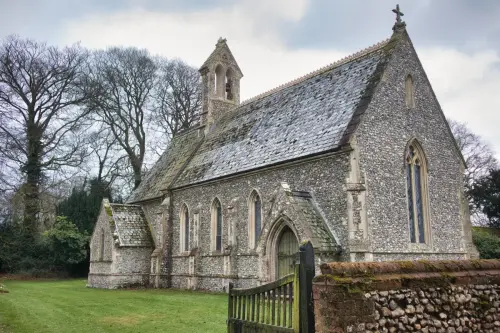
[128,39,395,202]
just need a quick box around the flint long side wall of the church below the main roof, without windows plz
[163,153,349,291]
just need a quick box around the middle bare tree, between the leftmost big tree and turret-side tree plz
[87,47,157,188]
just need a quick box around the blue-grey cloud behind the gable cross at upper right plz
[285,0,500,51]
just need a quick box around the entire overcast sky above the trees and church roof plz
[0,0,500,158]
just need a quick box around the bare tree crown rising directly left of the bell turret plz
[154,58,202,137]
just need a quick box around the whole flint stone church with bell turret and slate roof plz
[88,15,477,290]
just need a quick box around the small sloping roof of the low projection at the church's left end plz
[110,204,153,247]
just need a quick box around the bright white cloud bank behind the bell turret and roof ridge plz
[60,0,346,99]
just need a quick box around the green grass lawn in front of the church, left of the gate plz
[0,280,227,333]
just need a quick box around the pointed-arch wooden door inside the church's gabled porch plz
[277,227,299,278]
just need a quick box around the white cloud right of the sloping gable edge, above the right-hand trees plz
[417,48,500,159]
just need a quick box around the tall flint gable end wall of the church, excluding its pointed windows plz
[354,32,475,260]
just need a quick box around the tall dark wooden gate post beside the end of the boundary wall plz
[299,241,315,333]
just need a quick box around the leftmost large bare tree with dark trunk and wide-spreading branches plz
[0,37,90,230]
